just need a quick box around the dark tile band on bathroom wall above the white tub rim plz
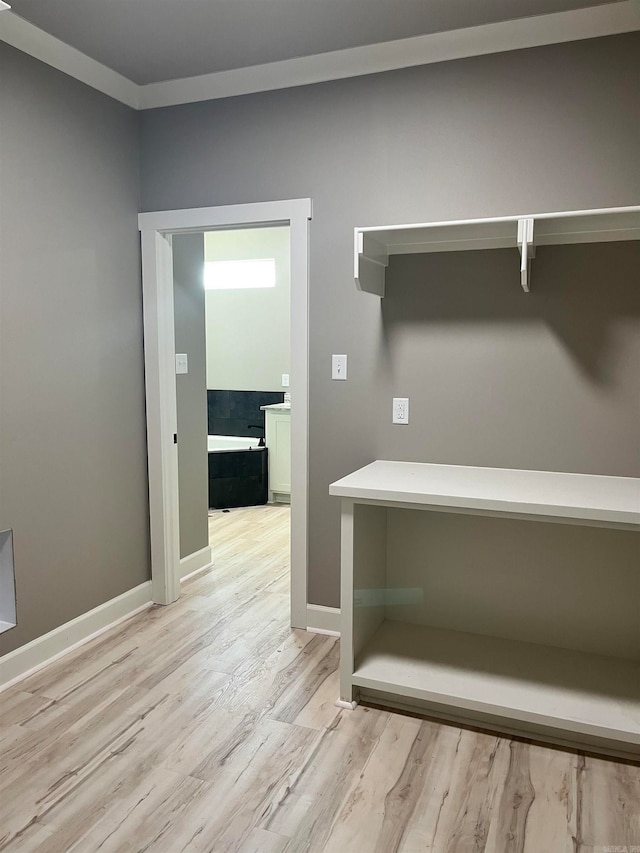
[207,390,284,438]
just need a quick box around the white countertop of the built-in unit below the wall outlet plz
[329,460,640,529]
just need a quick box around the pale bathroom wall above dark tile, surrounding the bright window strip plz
[204,227,291,391]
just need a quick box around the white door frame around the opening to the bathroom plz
[138,198,311,628]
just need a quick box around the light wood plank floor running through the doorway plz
[0,507,640,853]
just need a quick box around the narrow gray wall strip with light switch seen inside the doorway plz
[173,234,209,557]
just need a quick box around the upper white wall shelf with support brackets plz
[354,206,640,297]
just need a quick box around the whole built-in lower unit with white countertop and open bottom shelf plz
[330,461,640,758]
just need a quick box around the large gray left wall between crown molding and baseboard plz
[0,43,150,654]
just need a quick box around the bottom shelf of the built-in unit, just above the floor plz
[352,620,640,753]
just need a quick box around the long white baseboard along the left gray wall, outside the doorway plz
[0,581,153,691]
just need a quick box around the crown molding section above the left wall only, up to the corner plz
[0,12,140,109]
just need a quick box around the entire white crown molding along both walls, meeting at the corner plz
[0,0,640,110]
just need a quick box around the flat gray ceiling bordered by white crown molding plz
[3,0,615,85]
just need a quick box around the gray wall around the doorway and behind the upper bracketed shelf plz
[141,33,640,605]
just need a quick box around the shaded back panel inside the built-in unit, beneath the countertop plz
[382,507,640,660]
